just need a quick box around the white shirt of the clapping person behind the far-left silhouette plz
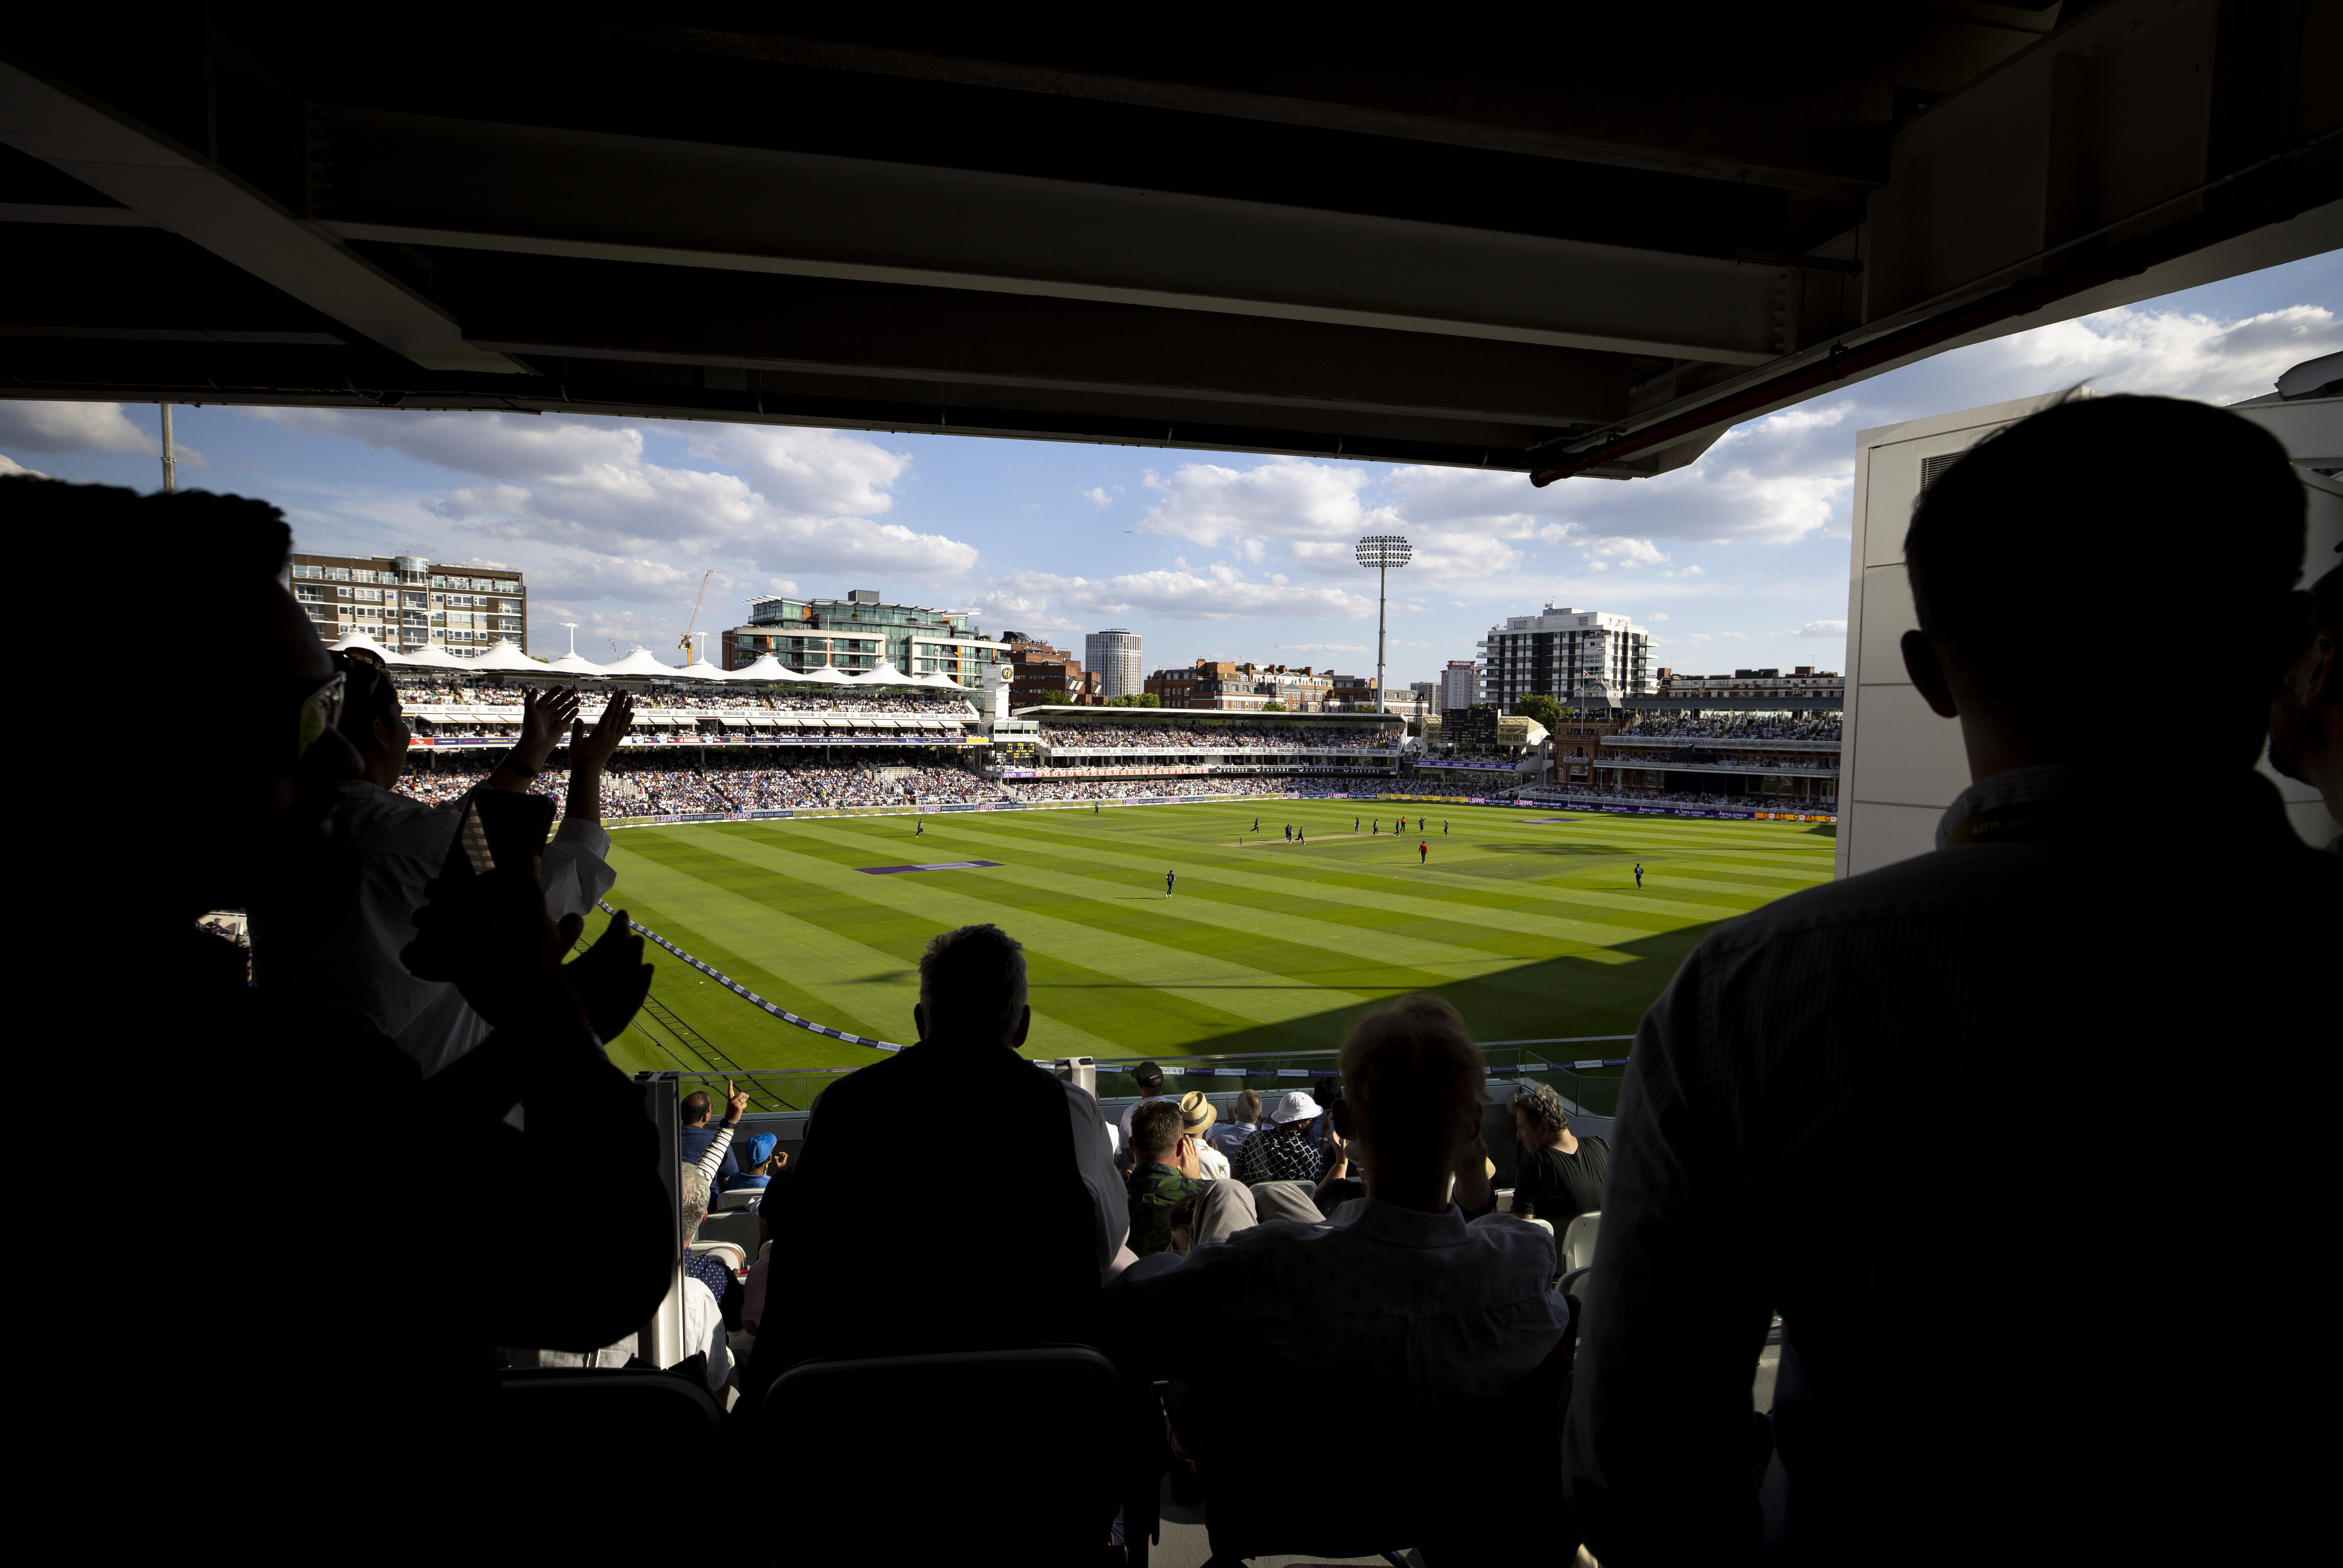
[251,778,618,1078]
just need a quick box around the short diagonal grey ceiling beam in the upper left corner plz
[0,61,520,373]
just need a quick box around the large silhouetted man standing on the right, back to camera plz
[1565,398,2343,1563]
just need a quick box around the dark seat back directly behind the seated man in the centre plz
[764,1345,1127,1561]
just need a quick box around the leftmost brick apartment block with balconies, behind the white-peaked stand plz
[293,555,530,659]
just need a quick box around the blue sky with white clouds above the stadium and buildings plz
[0,251,2343,687]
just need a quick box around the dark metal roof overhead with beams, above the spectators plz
[0,0,2343,483]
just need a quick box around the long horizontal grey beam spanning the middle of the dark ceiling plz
[314,108,1795,366]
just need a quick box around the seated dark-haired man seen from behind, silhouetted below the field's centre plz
[740,926,1129,1409]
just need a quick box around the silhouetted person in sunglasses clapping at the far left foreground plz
[21,478,675,1500]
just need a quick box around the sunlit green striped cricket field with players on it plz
[595,802,1832,1097]
